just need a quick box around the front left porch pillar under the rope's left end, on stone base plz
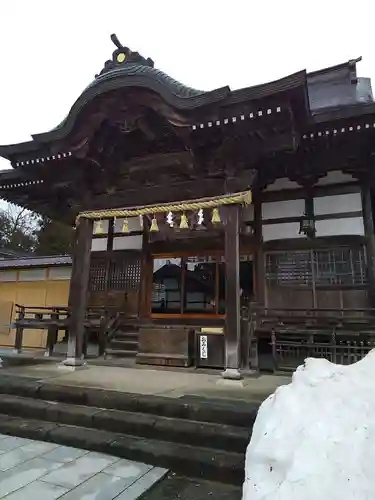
[64,218,93,366]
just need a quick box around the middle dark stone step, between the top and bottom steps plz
[0,394,250,453]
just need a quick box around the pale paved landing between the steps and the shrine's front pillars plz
[0,360,290,401]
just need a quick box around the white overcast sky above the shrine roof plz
[0,0,375,172]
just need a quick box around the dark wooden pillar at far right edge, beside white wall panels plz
[362,185,375,307]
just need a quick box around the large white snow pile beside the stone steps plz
[243,350,375,500]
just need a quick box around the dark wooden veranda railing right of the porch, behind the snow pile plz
[250,308,375,370]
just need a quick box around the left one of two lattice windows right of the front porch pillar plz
[265,250,312,285]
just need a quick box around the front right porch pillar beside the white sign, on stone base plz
[223,205,241,380]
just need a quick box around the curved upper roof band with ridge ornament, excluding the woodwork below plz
[0,35,310,159]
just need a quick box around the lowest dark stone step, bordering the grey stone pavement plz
[0,414,244,485]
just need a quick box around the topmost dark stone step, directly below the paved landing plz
[0,377,259,429]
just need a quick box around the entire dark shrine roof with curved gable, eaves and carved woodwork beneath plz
[0,35,375,222]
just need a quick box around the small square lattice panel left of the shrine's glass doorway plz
[108,255,141,291]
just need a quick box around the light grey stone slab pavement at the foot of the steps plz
[0,434,167,500]
